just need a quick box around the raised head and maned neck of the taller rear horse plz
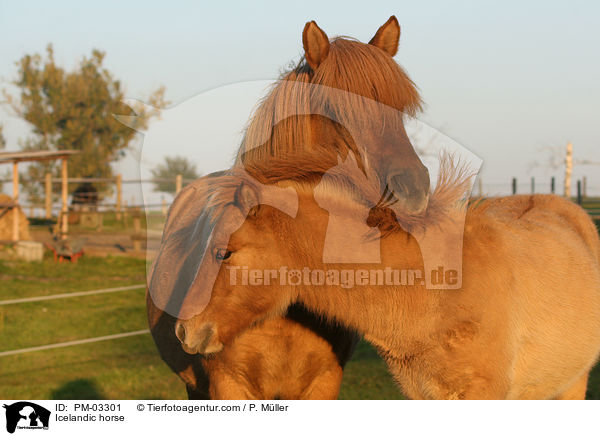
[237,16,429,214]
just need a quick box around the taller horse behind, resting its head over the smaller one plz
[147,17,429,398]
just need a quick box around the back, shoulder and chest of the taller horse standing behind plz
[146,175,357,400]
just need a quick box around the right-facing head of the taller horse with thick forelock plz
[302,16,430,214]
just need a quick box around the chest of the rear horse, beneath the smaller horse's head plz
[147,298,356,400]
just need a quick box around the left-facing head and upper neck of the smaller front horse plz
[168,157,394,354]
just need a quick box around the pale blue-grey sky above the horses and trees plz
[0,0,600,204]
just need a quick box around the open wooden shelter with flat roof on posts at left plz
[0,150,79,241]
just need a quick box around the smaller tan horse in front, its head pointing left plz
[173,158,600,399]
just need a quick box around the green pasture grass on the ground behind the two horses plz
[0,257,600,399]
